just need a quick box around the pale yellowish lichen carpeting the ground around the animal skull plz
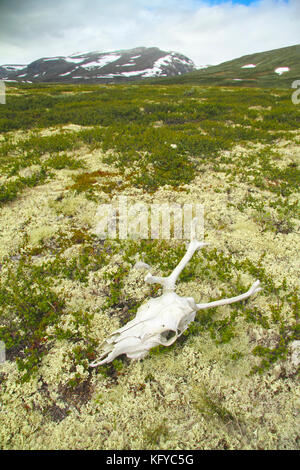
[0,120,299,450]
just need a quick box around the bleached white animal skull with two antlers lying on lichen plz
[90,218,261,367]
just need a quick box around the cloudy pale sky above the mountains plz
[0,0,300,65]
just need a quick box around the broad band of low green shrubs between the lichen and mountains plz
[0,81,298,193]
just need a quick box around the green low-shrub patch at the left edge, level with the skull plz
[0,259,65,381]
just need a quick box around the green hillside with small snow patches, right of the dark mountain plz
[146,44,300,88]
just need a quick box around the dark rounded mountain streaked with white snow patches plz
[0,47,196,83]
